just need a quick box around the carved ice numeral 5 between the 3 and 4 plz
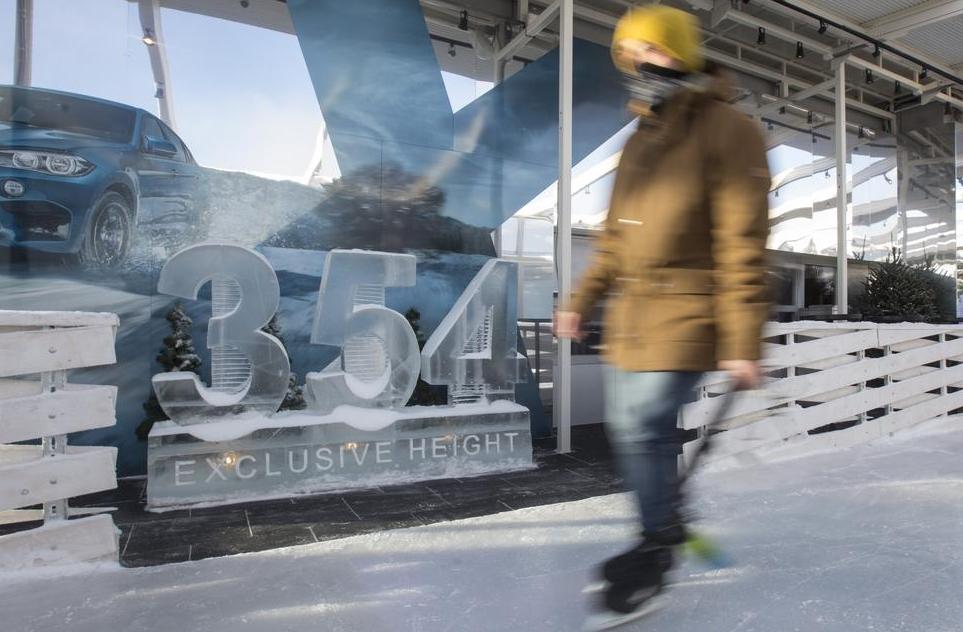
[305,250,419,413]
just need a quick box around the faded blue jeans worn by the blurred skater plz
[606,368,702,533]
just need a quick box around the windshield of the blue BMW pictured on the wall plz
[0,86,135,143]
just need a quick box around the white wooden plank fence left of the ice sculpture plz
[0,311,118,569]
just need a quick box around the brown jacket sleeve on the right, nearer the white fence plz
[710,110,771,360]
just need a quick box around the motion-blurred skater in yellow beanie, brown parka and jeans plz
[555,5,770,629]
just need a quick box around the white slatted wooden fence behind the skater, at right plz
[681,322,963,461]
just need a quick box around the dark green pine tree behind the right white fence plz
[861,248,940,322]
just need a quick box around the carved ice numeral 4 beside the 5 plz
[421,259,524,404]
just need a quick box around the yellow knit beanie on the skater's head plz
[612,5,703,72]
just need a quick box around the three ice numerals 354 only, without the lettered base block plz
[153,243,525,425]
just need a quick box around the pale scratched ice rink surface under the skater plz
[0,418,963,632]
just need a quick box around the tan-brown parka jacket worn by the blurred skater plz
[569,78,770,371]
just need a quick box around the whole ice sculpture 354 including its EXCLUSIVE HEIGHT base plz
[147,244,532,507]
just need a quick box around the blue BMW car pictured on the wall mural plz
[0,85,203,269]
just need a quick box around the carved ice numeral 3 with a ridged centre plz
[153,243,291,425]
